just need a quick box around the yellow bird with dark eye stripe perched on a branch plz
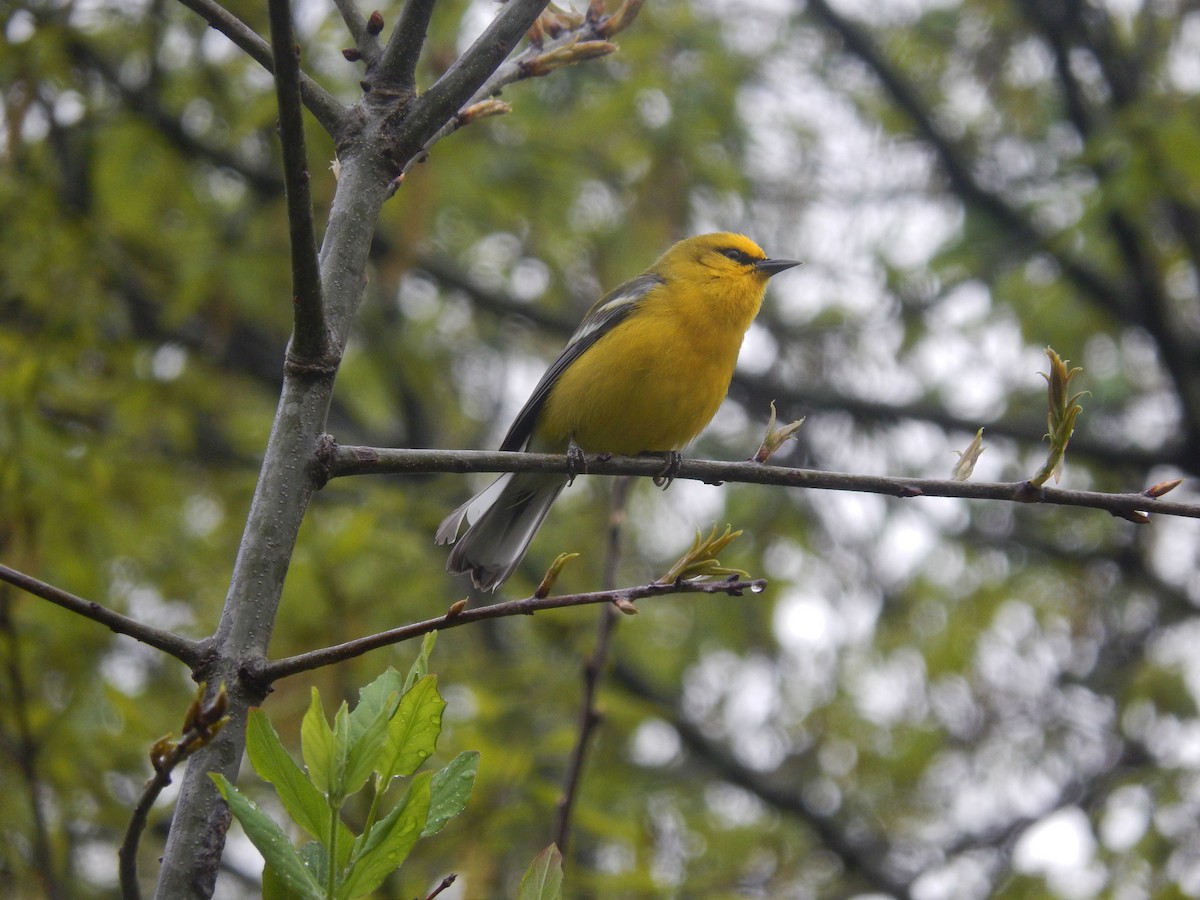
[437,233,799,590]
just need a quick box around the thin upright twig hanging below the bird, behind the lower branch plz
[554,478,632,865]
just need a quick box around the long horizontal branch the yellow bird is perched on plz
[328,446,1200,518]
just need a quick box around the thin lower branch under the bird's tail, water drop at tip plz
[266,578,767,684]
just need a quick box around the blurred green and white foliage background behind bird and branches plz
[0,0,1200,900]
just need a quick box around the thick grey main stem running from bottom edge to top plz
[156,0,546,900]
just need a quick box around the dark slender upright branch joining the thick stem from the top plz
[268,0,330,366]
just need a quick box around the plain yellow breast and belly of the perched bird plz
[535,304,749,456]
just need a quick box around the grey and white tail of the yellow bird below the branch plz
[438,473,566,590]
